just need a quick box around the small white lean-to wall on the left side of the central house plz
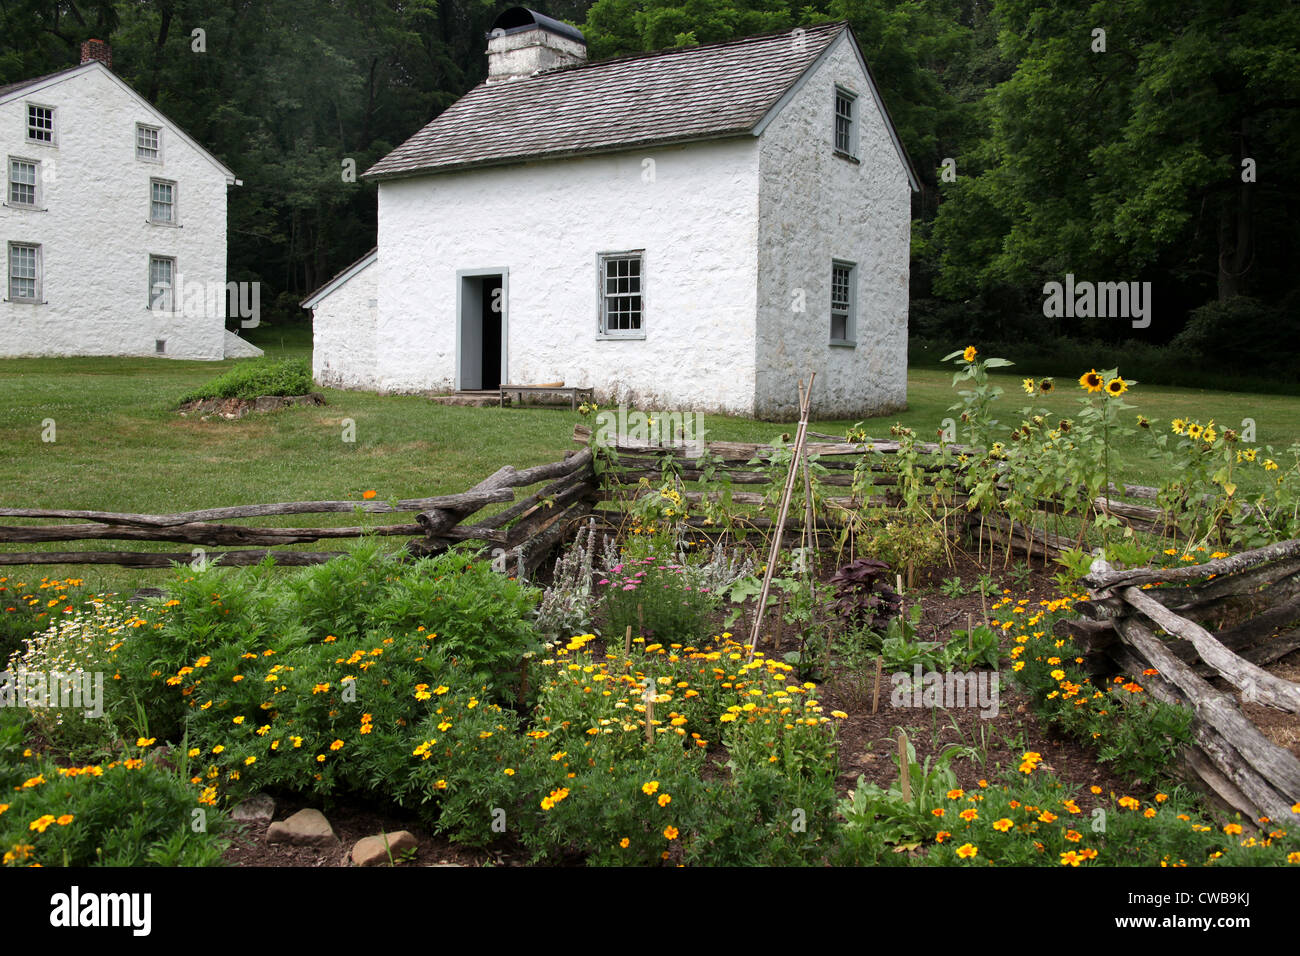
[312,260,380,389]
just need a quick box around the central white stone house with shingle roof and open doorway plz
[308,8,917,419]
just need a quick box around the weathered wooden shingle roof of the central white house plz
[364,22,848,179]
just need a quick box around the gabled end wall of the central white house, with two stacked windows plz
[755,34,911,419]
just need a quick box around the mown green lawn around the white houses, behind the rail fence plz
[0,326,1300,589]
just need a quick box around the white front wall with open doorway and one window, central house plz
[377,137,759,415]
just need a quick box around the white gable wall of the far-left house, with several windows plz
[0,66,226,359]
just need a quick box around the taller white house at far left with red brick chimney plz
[0,40,260,359]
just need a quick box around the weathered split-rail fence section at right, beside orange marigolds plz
[1066,541,1300,819]
